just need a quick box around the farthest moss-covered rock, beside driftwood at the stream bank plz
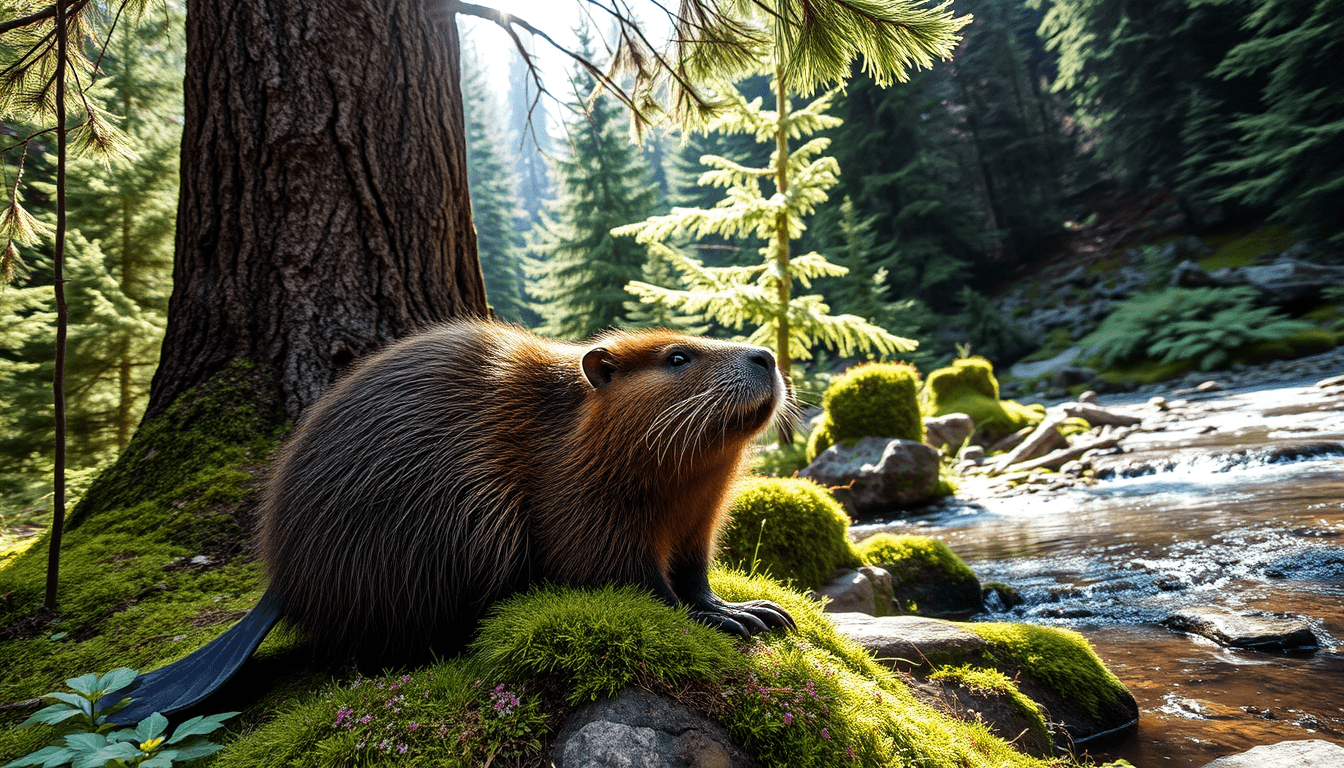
[921,356,1046,440]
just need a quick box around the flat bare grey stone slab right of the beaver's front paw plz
[831,613,989,668]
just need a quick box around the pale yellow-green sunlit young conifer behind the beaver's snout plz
[614,62,915,375]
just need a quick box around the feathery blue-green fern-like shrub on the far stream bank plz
[1083,286,1312,371]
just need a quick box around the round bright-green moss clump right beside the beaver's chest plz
[718,477,860,589]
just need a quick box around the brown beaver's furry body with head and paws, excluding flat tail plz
[259,320,793,664]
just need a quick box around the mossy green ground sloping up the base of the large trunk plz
[0,364,280,731]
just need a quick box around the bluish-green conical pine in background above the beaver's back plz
[528,30,657,339]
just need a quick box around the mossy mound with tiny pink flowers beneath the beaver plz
[214,569,1058,768]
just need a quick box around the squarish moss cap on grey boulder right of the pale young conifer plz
[821,363,923,443]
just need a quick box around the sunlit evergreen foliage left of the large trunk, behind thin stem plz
[0,8,183,512]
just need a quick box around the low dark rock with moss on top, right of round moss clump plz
[856,534,981,616]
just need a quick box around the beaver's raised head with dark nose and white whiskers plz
[579,331,792,464]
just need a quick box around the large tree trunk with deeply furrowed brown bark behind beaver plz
[145,0,487,420]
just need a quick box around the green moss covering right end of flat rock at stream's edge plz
[961,623,1129,717]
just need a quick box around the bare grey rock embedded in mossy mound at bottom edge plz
[547,687,759,768]
